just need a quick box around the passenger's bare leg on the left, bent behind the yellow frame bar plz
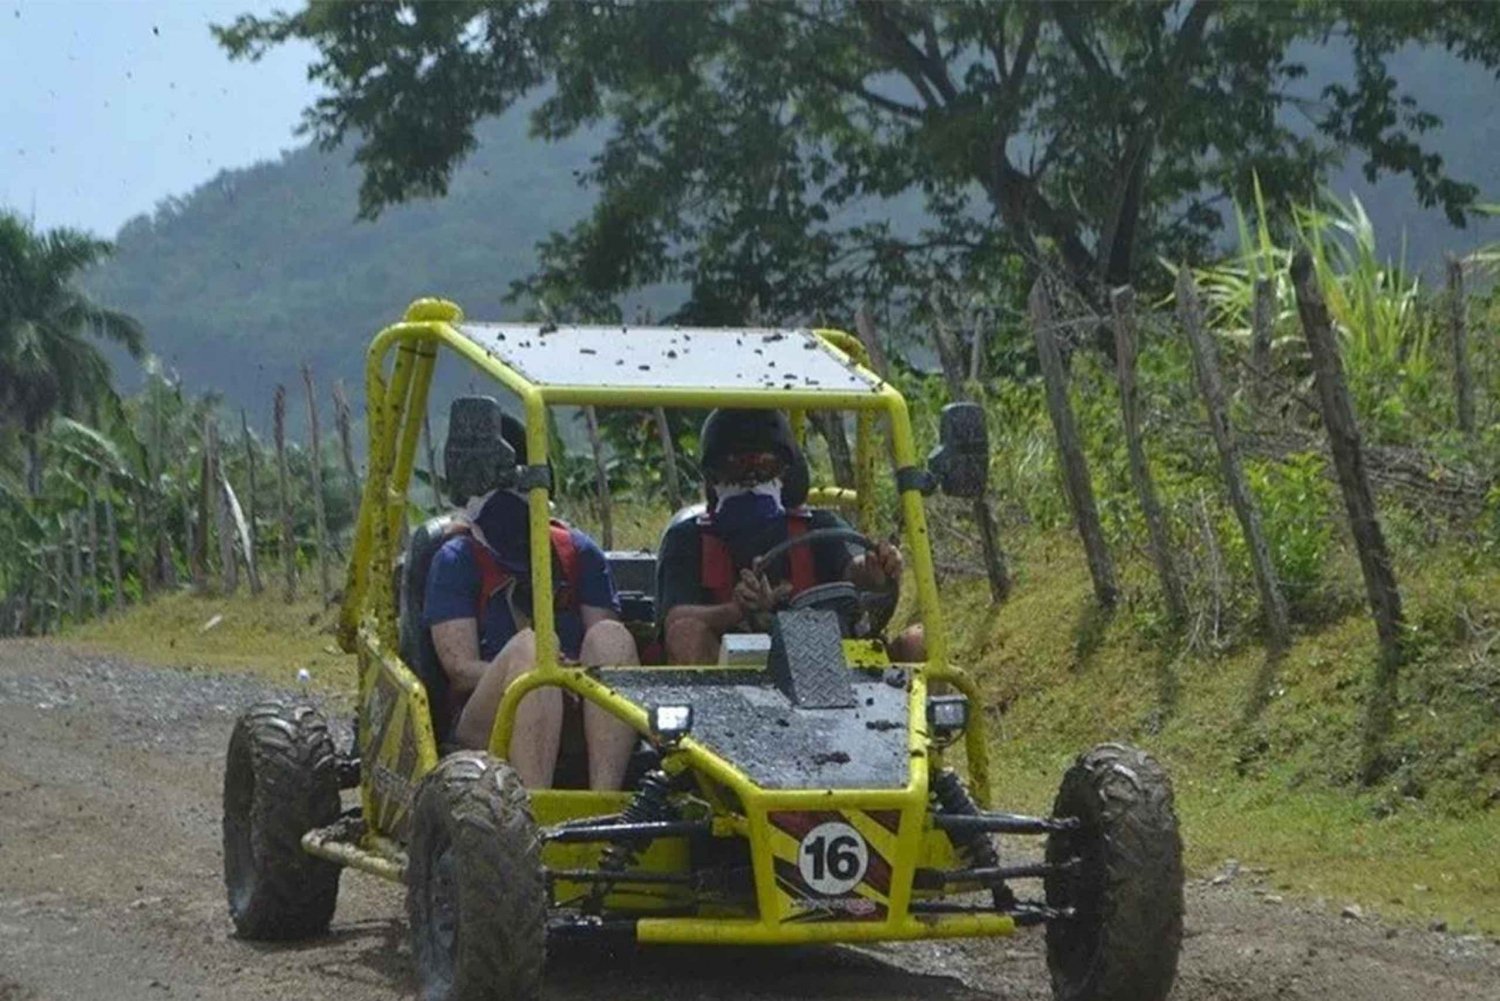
[455,629,563,789]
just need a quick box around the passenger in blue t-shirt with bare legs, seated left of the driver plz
[425,416,638,789]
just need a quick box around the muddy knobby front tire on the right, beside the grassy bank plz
[1046,744,1182,1001]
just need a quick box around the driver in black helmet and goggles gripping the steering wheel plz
[657,410,923,665]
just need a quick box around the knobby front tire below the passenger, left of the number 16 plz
[407,750,548,1001]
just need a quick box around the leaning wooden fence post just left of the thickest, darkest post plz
[1178,264,1292,653]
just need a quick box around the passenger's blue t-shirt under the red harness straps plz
[423,491,620,660]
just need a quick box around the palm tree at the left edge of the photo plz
[0,213,144,495]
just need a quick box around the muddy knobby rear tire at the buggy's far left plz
[224,702,341,939]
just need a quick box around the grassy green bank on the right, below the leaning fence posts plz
[945,537,1500,933]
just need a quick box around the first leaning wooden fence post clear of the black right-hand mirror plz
[1028,276,1119,608]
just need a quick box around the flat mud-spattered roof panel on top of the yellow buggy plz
[455,323,882,393]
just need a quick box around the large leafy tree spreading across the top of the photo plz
[218,0,1500,321]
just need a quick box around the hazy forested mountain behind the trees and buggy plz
[89,45,1500,426]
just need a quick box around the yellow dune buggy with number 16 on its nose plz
[224,300,1182,1001]
